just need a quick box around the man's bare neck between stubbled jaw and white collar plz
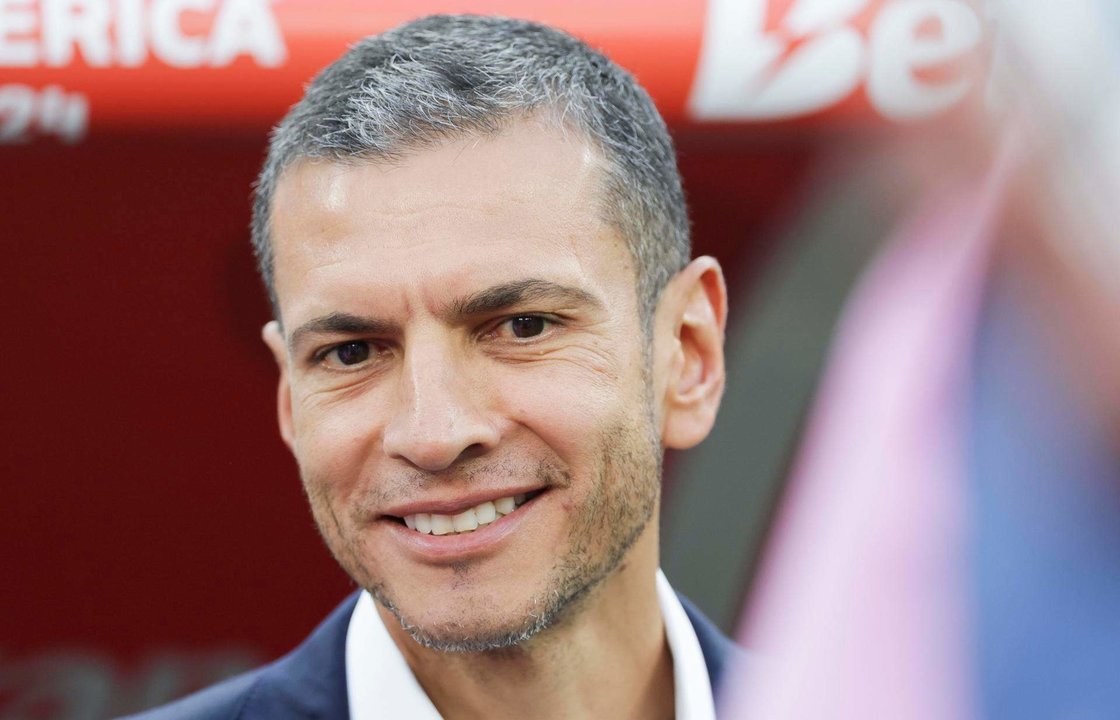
[377,523,674,720]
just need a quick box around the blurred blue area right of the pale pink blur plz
[969,267,1120,720]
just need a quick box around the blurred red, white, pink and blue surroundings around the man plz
[0,0,1120,719]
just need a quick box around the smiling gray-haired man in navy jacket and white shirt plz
[131,12,732,719]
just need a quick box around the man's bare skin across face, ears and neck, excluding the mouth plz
[263,120,726,718]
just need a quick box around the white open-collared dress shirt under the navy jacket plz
[346,570,716,720]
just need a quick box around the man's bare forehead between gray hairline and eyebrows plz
[271,121,635,324]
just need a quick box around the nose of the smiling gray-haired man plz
[383,343,500,473]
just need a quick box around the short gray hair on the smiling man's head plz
[252,16,690,329]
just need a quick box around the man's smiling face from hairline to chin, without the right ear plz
[267,122,661,648]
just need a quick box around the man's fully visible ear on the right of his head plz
[654,256,727,449]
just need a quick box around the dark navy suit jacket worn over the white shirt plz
[124,592,745,720]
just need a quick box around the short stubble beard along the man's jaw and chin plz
[304,405,662,653]
